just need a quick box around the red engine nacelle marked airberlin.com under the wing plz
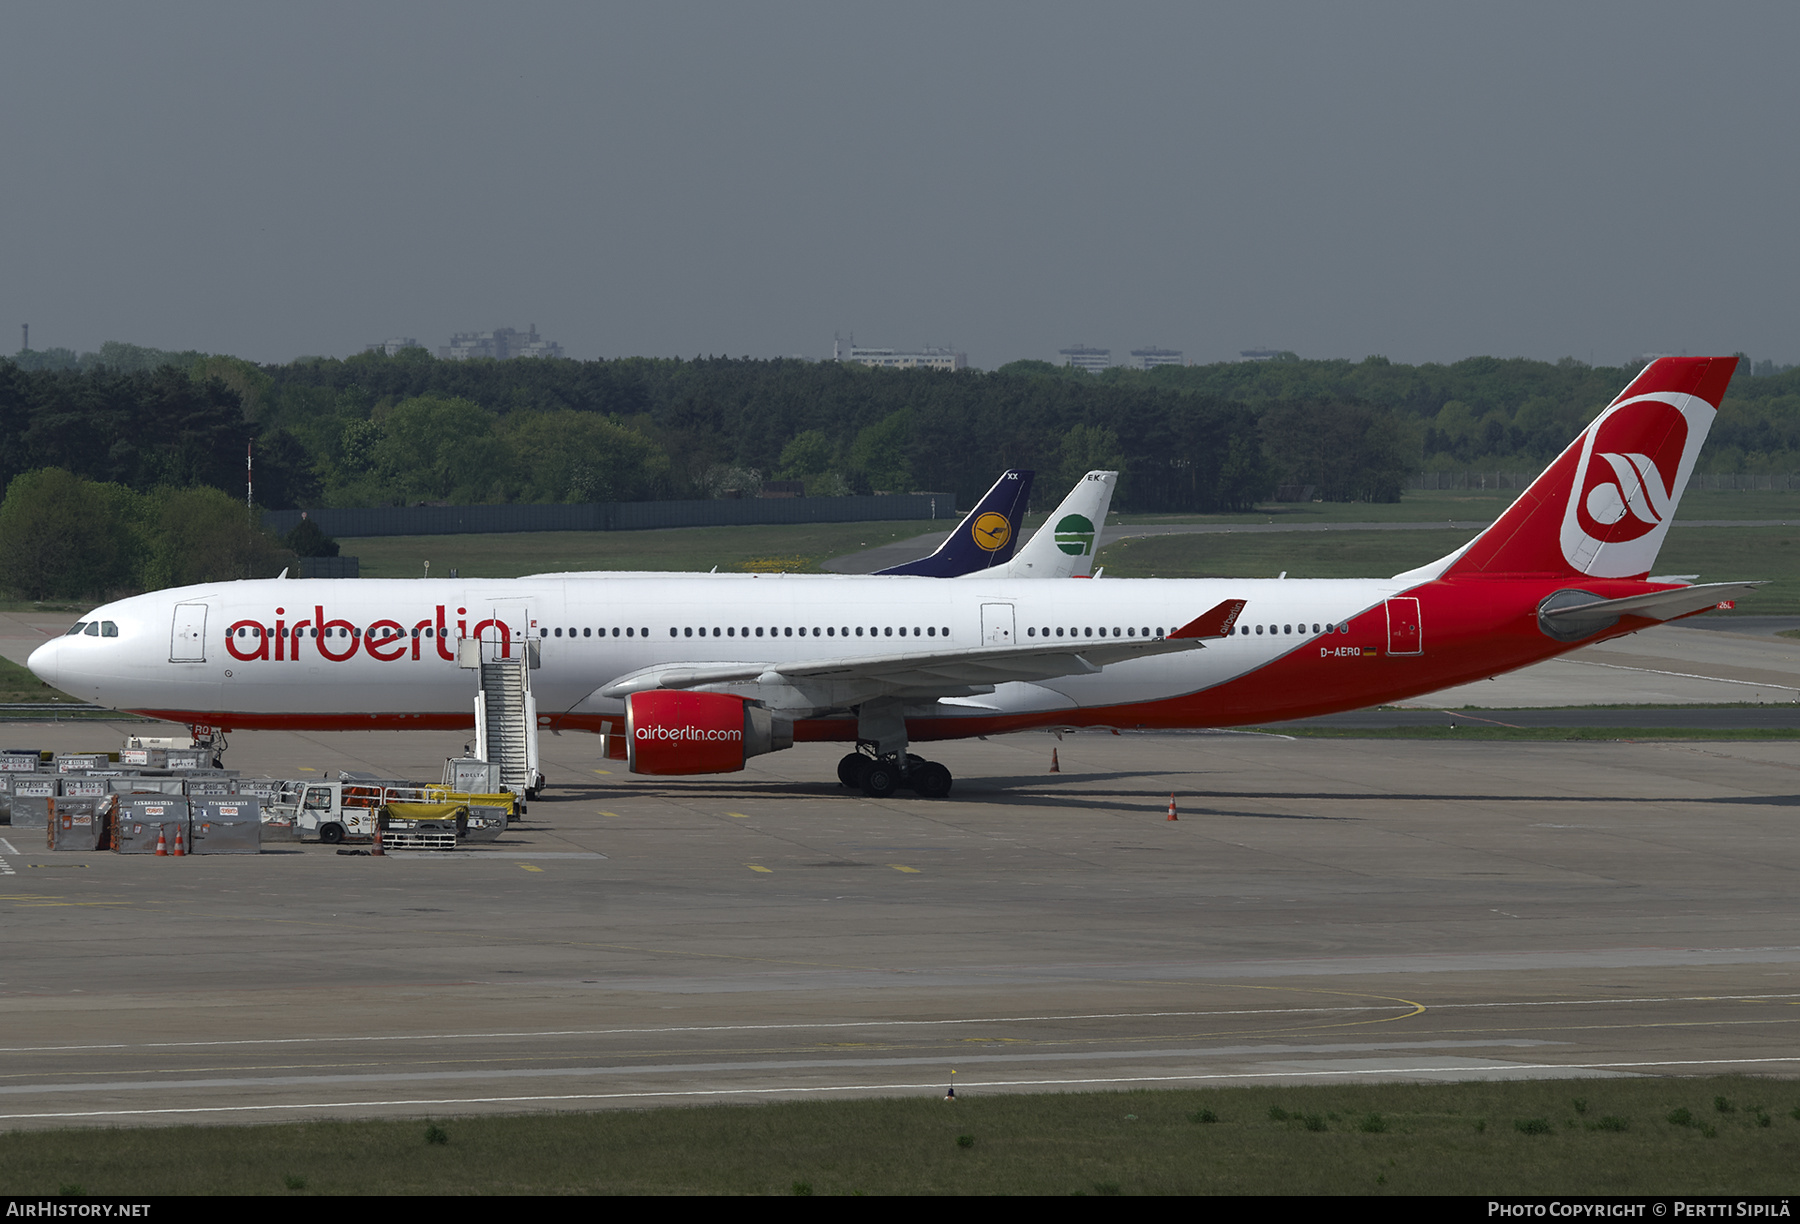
[625,689,794,774]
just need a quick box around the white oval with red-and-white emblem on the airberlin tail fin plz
[1562,392,1714,578]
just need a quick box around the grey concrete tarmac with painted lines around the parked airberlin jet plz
[0,586,1800,1127]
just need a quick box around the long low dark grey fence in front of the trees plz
[263,493,956,540]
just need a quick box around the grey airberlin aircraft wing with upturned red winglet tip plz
[596,599,1244,706]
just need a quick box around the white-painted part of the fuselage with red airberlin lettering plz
[31,574,1408,725]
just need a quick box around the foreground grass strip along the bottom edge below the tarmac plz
[0,1076,1800,1195]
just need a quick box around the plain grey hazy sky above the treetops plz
[0,2,1800,369]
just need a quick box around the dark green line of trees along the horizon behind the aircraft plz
[0,344,1800,550]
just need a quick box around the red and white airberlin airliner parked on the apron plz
[31,358,1757,797]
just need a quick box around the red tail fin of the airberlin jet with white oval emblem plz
[1444,356,1737,578]
